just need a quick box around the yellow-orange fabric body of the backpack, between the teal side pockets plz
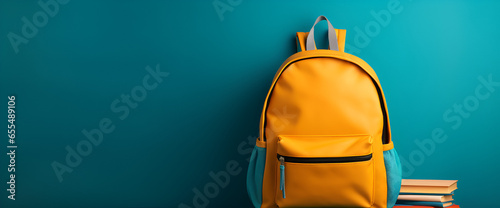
[260,49,391,208]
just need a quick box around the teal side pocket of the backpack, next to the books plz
[384,148,403,208]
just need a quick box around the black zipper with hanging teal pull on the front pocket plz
[278,154,372,199]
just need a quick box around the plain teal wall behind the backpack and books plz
[0,0,500,207]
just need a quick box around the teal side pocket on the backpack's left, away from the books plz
[247,146,266,208]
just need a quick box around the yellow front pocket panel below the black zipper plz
[276,160,374,207]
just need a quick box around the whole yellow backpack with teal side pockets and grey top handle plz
[247,16,401,208]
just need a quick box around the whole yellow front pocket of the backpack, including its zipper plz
[276,135,374,207]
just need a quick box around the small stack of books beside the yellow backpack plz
[394,179,459,208]
